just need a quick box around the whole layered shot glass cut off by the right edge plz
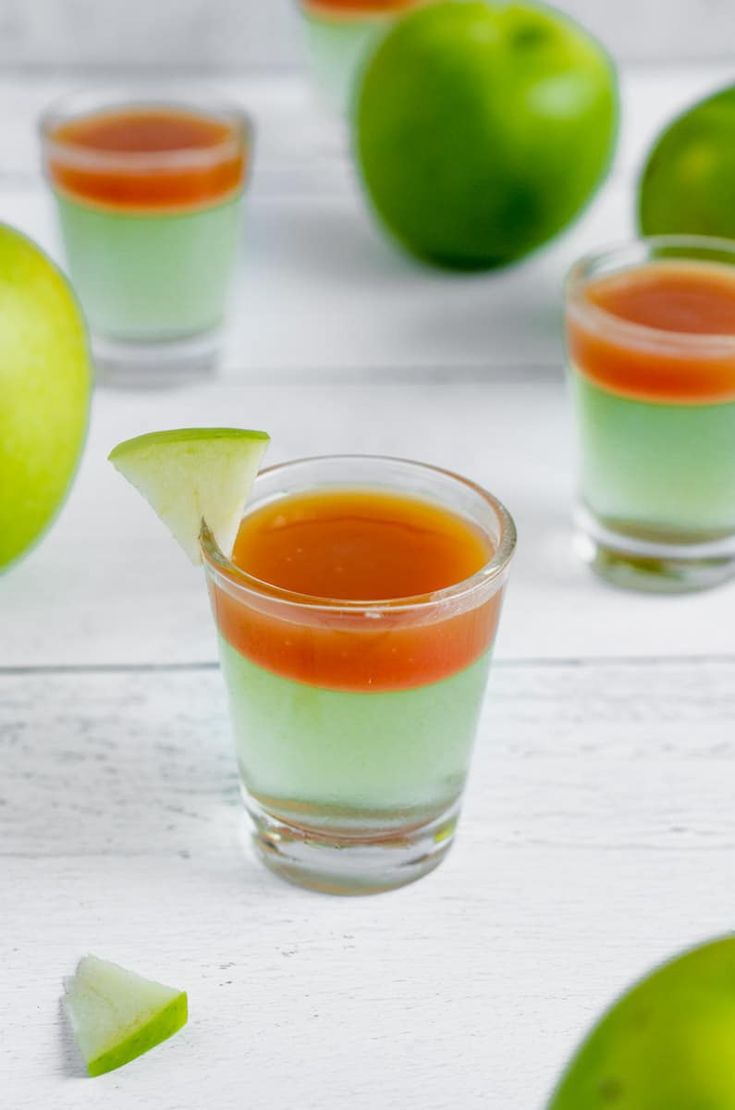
[566,236,735,592]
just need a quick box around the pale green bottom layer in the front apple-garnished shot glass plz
[220,639,490,831]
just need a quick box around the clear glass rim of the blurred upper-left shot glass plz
[38,85,254,172]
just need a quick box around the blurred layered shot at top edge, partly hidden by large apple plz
[300,0,425,115]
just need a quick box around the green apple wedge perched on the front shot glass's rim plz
[110,427,270,564]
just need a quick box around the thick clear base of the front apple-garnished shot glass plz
[245,797,459,895]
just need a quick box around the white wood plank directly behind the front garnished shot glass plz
[0,375,735,666]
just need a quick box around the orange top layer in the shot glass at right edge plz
[567,261,735,404]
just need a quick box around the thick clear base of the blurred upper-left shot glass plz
[92,331,221,390]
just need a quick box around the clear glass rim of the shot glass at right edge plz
[565,234,735,354]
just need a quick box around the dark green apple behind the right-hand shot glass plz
[638,87,735,239]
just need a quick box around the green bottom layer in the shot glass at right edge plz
[572,372,735,543]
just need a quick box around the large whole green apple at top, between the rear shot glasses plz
[354,0,618,270]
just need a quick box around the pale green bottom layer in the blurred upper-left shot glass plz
[57,195,242,342]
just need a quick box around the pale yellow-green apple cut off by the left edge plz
[0,224,92,571]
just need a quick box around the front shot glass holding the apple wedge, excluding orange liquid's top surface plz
[202,456,515,895]
